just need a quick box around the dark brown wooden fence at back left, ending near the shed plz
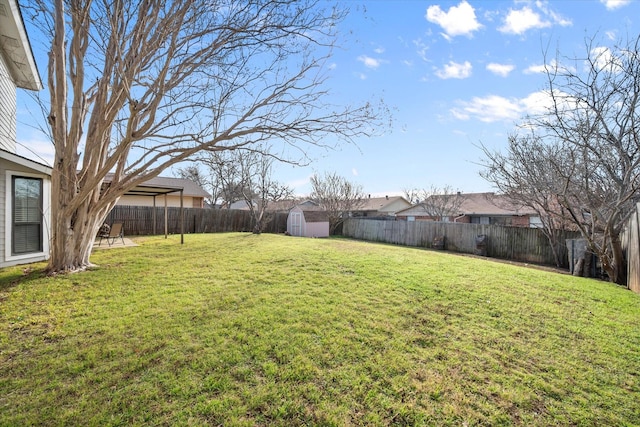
[106,206,287,236]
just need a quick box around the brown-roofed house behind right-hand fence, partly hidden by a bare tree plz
[396,193,541,227]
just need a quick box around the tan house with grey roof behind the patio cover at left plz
[104,174,211,208]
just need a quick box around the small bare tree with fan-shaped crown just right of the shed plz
[311,172,365,234]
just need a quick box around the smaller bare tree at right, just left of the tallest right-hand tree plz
[480,135,571,267]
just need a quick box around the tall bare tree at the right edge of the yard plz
[482,37,640,285]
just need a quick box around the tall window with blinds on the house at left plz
[12,176,42,255]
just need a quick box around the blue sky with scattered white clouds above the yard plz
[13,0,640,195]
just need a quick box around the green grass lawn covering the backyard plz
[0,233,640,426]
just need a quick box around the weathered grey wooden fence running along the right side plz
[342,218,577,267]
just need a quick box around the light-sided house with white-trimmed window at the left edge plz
[0,0,51,267]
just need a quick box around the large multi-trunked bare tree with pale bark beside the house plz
[26,0,386,272]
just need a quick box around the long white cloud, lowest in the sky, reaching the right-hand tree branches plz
[450,91,551,123]
